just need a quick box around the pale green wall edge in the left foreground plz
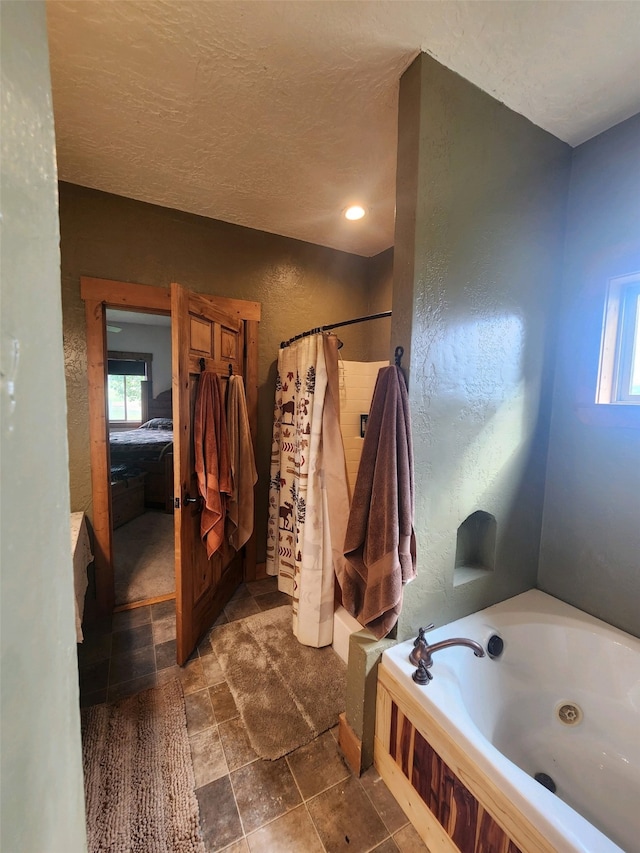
[0,0,87,853]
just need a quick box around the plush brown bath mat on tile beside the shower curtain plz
[211,606,346,759]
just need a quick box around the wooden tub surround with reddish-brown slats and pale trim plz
[374,666,555,853]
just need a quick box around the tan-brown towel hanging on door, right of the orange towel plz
[227,375,258,551]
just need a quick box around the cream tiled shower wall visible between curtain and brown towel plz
[338,360,389,495]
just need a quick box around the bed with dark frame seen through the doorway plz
[109,391,173,516]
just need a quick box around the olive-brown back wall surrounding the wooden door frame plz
[60,183,390,560]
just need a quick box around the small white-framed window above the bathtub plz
[596,273,640,405]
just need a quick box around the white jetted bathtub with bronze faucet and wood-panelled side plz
[374,590,640,853]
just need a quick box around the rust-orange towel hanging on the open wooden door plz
[193,370,231,558]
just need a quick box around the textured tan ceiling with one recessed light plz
[47,0,640,255]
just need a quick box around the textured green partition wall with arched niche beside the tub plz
[392,54,570,639]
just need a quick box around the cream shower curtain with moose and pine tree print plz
[267,333,349,648]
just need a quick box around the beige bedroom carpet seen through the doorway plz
[113,510,176,605]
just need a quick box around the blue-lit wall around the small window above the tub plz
[538,115,640,636]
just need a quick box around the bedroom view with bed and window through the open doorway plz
[105,308,175,610]
